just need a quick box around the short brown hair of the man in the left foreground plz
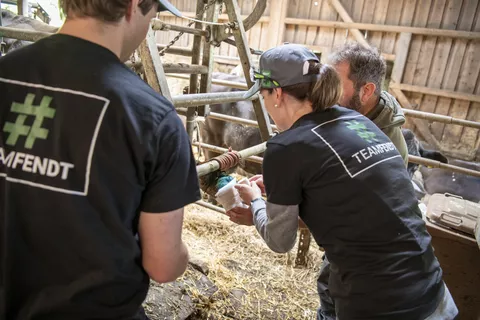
[60,0,157,22]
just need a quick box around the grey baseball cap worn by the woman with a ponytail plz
[243,43,320,99]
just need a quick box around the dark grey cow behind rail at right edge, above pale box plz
[420,159,480,203]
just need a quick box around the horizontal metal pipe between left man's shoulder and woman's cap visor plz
[172,91,258,108]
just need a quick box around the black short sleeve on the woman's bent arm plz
[263,143,302,205]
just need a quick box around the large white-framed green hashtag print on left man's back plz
[0,78,110,196]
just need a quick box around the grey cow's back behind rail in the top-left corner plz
[1,10,58,53]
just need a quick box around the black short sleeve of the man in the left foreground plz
[141,111,200,213]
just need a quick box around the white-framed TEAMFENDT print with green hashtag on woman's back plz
[312,115,401,178]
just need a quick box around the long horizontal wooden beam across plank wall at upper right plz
[285,18,480,40]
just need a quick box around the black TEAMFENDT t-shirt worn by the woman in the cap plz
[263,106,444,320]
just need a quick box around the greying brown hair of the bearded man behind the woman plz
[328,42,387,96]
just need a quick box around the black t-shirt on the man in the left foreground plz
[0,35,200,320]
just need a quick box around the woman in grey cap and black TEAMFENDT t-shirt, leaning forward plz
[227,44,458,320]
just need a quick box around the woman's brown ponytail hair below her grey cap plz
[268,61,342,112]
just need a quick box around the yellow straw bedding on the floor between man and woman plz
[146,205,323,320]
